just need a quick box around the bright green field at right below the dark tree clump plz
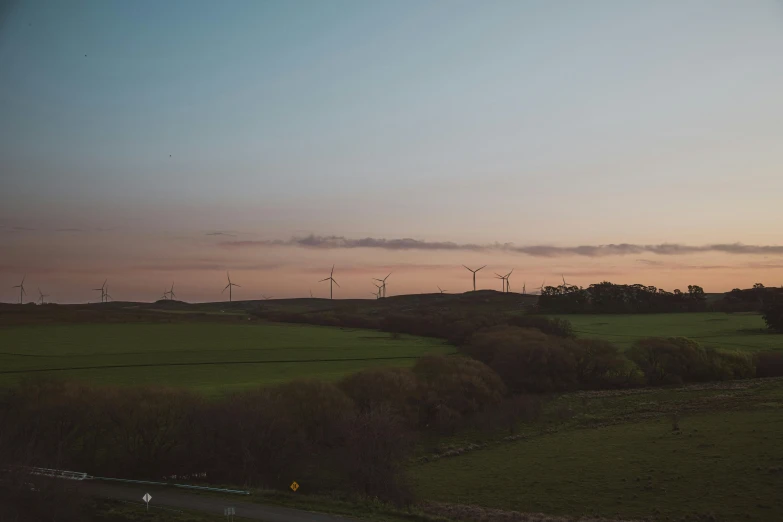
[555,312,783,352]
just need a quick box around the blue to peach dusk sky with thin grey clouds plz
[0,0,783,303]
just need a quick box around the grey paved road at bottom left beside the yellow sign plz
[80,482,358,522]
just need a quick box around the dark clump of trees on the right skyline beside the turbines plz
[538,281,706,314]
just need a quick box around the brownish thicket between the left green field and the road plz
[0,356,533,501]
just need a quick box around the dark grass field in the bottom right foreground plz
[412,379,783,521]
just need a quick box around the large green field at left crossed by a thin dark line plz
[0,323,454,393]
